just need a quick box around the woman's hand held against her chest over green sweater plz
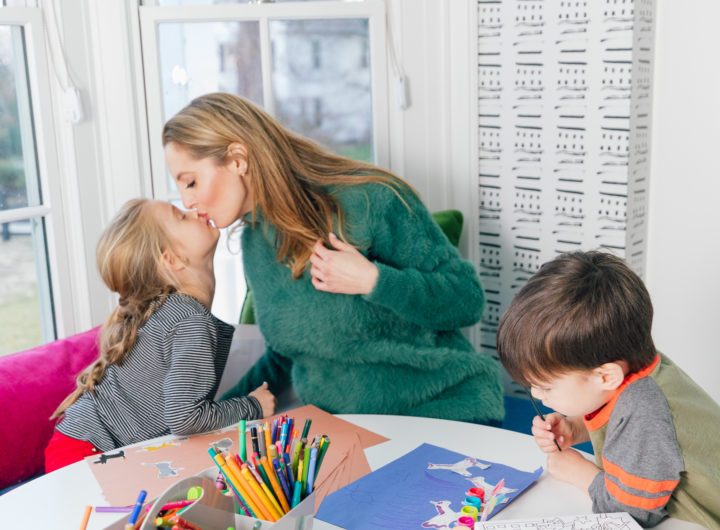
[310,234,378,294]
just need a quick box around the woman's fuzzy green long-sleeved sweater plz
[223,184,504,424]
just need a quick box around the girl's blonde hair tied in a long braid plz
[51,199,176,419]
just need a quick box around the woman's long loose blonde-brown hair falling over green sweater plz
[162,93,414,278]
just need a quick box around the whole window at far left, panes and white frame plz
[0,8,70,355]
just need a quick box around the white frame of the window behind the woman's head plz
[139,0,390,200]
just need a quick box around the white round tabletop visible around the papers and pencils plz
[0,414,702,530]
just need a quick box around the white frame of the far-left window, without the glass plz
[0,7,74,342]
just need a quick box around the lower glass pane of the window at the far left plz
[0,218,55,355]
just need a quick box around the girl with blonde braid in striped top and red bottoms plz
[45,199,275,472]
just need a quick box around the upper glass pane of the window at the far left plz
[0,26,42,210]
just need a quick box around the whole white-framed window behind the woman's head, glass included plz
[140,0,389,321]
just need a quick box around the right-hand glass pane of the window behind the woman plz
[270,19,373,162]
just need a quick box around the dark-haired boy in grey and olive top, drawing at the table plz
[498,252,720,528]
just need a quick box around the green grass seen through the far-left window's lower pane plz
[0,293,43,356]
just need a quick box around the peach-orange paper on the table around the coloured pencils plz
[85,405,387,509]
